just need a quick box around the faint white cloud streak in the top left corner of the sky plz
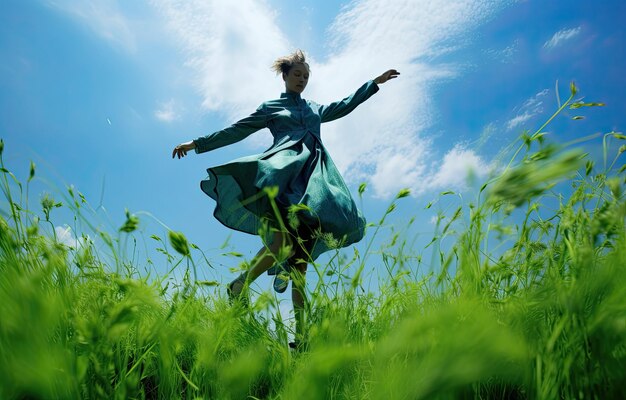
[45,0,136,53]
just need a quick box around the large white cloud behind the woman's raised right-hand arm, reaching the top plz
[311,0,499,197]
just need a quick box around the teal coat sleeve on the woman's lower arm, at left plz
[193,104,267,153]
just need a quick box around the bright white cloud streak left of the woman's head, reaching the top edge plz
[153,0,292,119]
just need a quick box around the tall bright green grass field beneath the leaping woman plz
[0,85,626,399]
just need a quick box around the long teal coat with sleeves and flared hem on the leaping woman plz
[194,81,378,259]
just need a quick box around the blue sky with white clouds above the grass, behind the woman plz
[0,0,626,288]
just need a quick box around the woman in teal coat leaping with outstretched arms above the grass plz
[172,50,400,340]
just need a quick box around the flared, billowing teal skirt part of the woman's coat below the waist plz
[200,133,365,260]
